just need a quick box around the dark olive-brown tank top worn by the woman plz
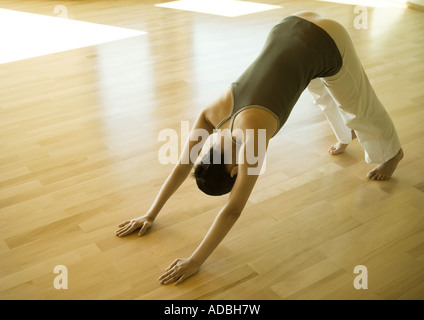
[217,16,342,135]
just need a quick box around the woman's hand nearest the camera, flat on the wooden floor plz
[159,258,200,285]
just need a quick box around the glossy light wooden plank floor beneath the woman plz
[0,0,424,299]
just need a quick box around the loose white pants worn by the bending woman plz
[308,13,401,164]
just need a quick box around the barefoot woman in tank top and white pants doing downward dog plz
[116,12,403,284]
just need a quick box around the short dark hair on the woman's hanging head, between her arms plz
[193,146,237,196]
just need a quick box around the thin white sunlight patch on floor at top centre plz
[156,0,281,17]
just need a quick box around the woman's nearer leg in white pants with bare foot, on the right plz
[320,19,403,180]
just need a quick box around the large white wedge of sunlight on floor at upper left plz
[0,9,146,63]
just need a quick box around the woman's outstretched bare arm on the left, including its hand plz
[116,111,214,237]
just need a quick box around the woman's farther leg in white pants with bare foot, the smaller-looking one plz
[308,78,355,155]
